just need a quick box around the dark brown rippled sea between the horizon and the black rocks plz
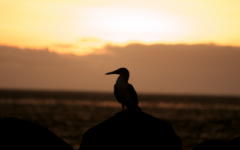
[0,90,240,150]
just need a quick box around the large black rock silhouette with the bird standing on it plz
[79,110,182,150]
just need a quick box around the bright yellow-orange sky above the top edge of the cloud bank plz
[0,0,240,54]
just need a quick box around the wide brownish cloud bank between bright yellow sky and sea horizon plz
[0,44,240,95]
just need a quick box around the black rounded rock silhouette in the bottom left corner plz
[0,118,73,150]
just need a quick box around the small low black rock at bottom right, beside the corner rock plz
[193,140,225,150]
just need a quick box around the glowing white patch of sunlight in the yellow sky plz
[80,8,190,42]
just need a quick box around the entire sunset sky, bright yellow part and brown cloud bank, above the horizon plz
[0,0,240,96]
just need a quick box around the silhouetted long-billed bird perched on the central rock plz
[105,68,141,111]
